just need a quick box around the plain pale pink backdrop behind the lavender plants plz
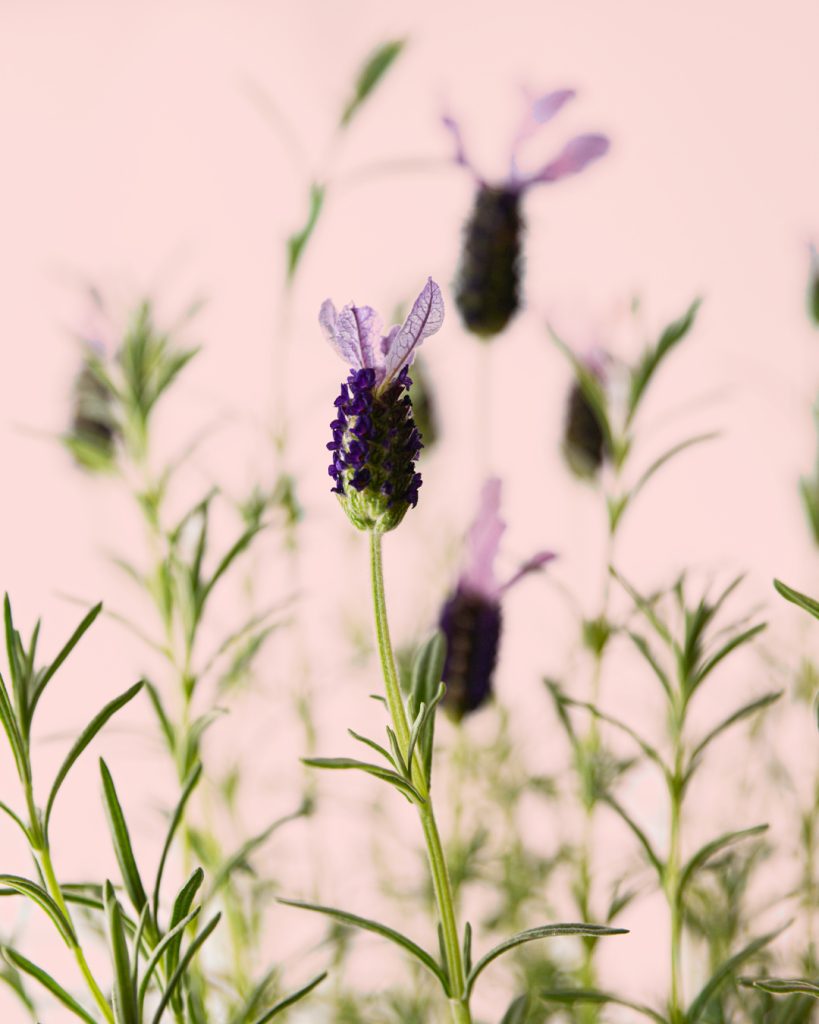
[0,0,819,1022]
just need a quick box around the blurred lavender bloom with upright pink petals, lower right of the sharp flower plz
[439,477,555,721]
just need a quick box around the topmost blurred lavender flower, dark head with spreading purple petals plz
[443,89,609,338]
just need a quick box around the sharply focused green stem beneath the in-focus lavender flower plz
[370,530,472,1024]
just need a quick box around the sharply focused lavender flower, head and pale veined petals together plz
[318,278,443,534]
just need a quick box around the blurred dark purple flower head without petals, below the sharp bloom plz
[439,588,502,721]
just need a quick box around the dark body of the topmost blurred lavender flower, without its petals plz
[455,185,523,339]
